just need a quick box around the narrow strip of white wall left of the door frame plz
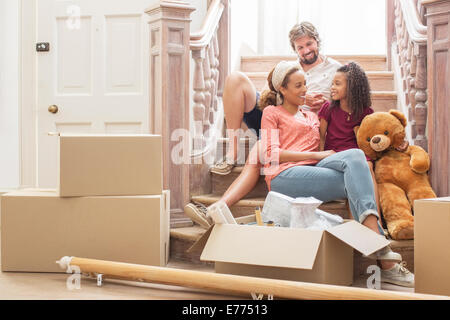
[0,0,20,189]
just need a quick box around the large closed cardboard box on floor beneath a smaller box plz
[1,190,170,272]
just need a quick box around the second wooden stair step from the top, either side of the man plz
[246,71,394,91]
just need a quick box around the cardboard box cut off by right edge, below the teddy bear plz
[414,197,450,296]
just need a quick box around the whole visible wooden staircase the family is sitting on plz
[170,55,414,276]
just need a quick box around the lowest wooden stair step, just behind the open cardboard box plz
[170,225,414,277]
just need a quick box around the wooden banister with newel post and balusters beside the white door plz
[146,0,230,227]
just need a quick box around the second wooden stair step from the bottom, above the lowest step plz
[192,194,351,219]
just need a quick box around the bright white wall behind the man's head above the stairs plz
[236,0,387,59]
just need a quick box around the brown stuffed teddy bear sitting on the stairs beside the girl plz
[355,110,436,240]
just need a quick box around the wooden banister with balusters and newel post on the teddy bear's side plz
[387,0,450,196]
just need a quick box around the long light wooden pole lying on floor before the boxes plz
[57,257,450,300]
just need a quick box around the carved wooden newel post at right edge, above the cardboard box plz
[422,0,450,196]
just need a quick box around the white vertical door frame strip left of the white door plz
[19,0,39,188]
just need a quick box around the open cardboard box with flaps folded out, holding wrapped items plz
[190,221,389,285]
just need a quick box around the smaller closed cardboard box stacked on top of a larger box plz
[58,133,163,197]
